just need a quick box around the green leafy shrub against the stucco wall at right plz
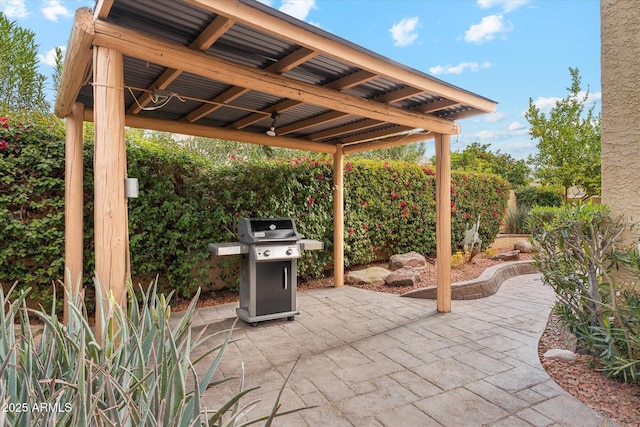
[531,204,640,381]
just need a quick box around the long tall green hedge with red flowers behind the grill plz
[0,111,509,296]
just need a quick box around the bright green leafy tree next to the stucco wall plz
[525,68,601,200]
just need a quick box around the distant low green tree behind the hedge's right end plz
[451,142,531,188]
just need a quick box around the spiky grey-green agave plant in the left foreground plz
[0,281,310,427]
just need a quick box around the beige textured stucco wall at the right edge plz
[600,0,640,245]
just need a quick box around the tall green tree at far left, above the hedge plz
[0,13,49,111]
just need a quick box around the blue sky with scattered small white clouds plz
[0,0,601,158]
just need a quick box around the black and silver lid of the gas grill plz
[238,218,300,243]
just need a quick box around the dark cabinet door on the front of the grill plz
[256,261,296,316]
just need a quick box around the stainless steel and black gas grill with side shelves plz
[208,218,324,326]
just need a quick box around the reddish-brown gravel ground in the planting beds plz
[181,254,640,427]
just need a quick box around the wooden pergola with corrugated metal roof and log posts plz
[55,0,496,322]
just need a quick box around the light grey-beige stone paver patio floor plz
[193,274,619,427]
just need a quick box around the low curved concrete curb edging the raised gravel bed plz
[401,260,538,300]
